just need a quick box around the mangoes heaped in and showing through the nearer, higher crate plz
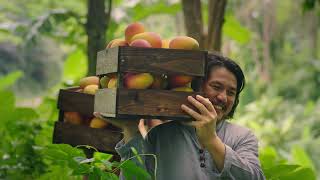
[101,22,199,92]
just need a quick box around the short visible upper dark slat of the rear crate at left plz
[58,88,94,116]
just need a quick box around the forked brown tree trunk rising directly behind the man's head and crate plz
[182,0,227,51]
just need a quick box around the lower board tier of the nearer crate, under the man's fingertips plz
[95,89,203,120]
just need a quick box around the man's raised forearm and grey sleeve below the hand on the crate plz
[207,132,265,180]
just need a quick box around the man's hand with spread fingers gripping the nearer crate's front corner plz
[181,95,217,148]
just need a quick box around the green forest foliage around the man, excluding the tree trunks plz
[0,0,320,179]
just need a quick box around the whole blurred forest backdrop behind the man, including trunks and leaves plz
[0,0,320,179]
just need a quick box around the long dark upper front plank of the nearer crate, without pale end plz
[119,47,207,76]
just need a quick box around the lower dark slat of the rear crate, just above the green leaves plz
[53,122,122,153]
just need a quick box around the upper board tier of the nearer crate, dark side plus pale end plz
[97,46,207,77]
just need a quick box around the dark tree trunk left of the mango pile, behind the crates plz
[86,0,112,76]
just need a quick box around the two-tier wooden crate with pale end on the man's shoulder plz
[94,47,207,120]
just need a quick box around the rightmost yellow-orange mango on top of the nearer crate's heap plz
[169,36,199,50]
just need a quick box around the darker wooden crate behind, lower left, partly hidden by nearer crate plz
[53,87,122,154]
